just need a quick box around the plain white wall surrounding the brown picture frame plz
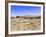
[0,0,46,37]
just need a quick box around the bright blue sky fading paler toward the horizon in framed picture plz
[11,5,41,16]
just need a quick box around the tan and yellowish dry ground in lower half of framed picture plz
[11,17,41,31]
